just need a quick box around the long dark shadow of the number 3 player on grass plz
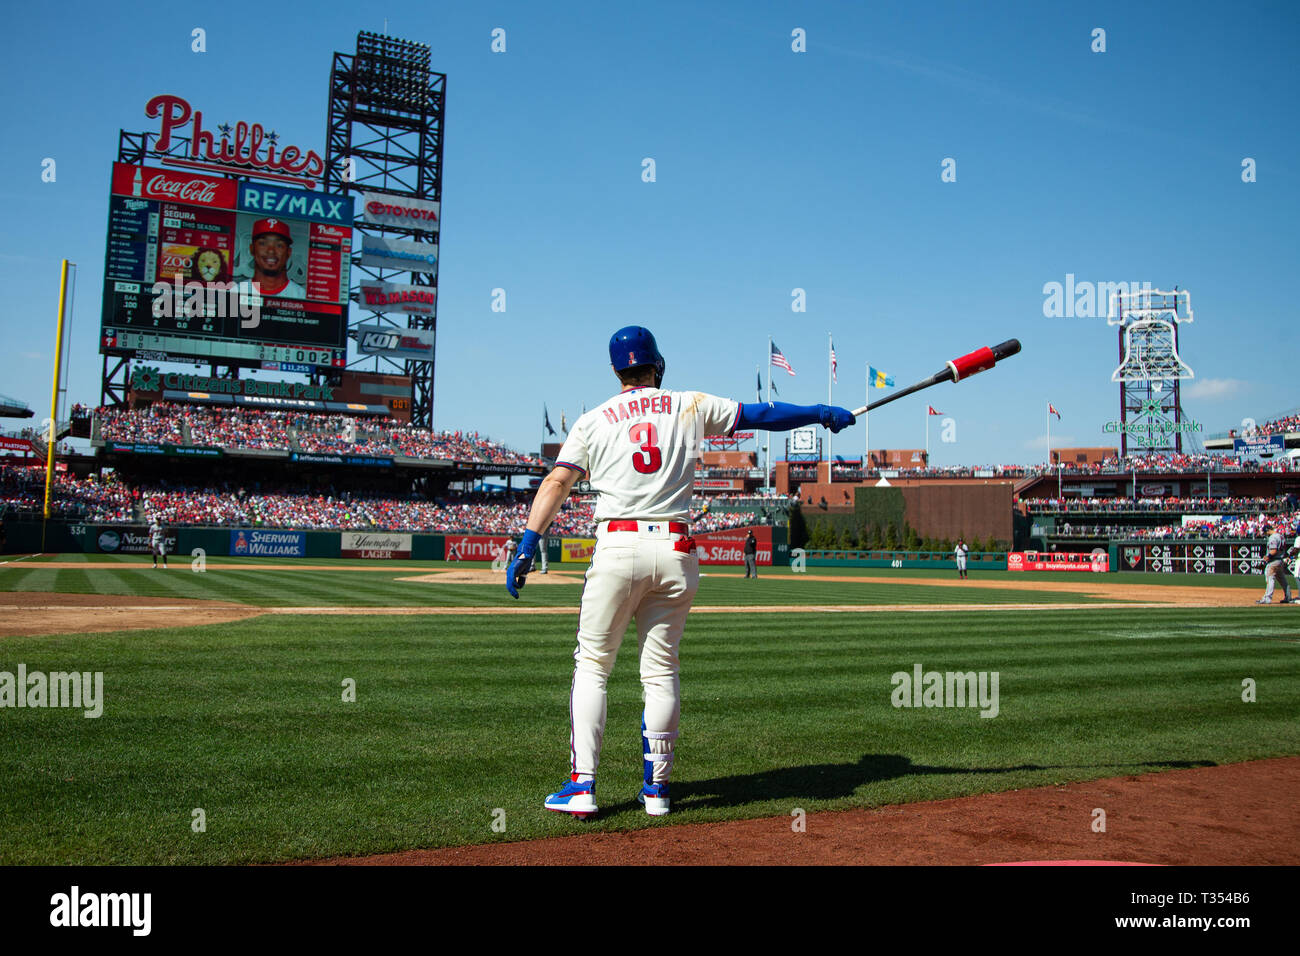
[611,753,1214,810]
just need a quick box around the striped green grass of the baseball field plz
[0,555,1300,864]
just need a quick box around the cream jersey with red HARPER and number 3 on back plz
[555,386,740,522]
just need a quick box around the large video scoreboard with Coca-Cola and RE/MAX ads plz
[100,163,352,368]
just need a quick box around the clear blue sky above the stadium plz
[0,1,1300,464]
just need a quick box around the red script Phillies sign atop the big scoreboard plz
[144,94,325,189]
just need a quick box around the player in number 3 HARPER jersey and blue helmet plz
[506,325,854,818]
